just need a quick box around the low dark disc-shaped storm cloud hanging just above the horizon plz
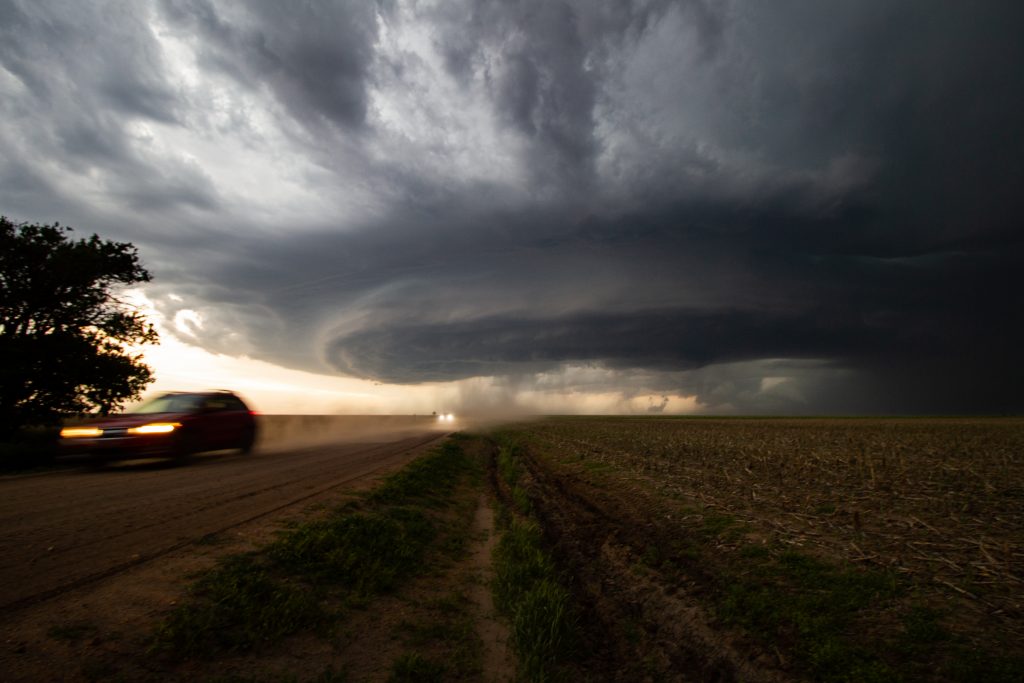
[237,192,1022,412]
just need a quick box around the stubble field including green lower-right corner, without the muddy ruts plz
[519,418,1024,680]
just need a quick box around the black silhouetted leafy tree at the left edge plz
[0,217,157,438]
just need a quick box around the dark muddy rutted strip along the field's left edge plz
[509,444,790,683]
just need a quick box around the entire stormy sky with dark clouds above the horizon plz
[0,0,1024,415]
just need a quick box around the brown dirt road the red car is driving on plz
[0,429,440,617]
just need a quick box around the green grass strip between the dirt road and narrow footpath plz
[154,440,474,658]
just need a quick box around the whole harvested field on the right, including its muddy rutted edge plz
[487,418,1024,681]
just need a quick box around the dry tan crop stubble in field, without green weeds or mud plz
[512,418,1024,679]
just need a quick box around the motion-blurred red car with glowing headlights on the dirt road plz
[60,391,256,465]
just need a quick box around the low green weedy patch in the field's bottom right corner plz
[717,546,1024,683]
